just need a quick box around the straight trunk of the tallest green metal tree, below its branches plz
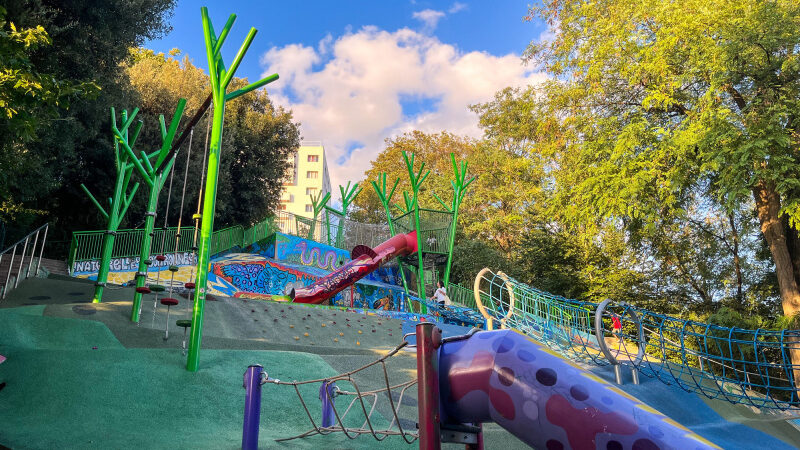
[186,95,225,372]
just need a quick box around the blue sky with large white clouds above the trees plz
[145,0,545,190]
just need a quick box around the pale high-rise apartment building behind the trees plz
[278,141,331,218]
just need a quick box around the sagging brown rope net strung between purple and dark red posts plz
[264,341,419,444]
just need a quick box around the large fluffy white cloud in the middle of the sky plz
[261,27,544,194]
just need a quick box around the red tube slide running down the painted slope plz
[289,231,417,303]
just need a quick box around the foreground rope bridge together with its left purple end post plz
[242,338,419,448]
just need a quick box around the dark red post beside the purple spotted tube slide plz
[416,322,442,450]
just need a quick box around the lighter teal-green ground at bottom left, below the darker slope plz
[0,349,418,449]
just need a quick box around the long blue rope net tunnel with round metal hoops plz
[474,269,800,410]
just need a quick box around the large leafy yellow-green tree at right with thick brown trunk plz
[526,0,800,383]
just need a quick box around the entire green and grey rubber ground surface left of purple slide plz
[0,279,526,449]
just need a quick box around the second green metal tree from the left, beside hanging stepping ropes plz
[126,99,186,322]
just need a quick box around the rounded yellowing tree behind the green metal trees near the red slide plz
[351,131,540,255]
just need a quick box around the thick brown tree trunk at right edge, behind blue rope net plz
[753,182,800,388]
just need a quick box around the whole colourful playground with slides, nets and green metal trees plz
[0,4,800,450]
